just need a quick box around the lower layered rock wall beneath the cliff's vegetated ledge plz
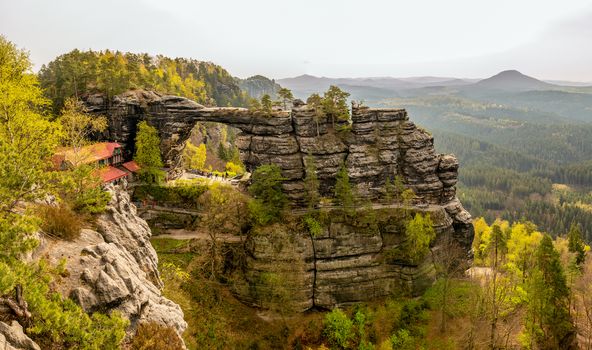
[233,206,455,311]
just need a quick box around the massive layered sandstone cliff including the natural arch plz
[87,91,473,309]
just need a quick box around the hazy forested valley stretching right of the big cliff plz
[383,92,592,240]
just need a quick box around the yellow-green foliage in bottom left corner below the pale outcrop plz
[0,261,128,350]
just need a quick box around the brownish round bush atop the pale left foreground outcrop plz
[38,205,82,241]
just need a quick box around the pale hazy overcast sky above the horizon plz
[0,0,592,81]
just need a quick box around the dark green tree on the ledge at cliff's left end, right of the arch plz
[249,164,287,225]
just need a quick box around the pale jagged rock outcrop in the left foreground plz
[34,187,187,346]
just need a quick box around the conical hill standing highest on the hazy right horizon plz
[469,70,559,92]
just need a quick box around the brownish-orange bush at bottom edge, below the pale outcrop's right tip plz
[130,322,183,350]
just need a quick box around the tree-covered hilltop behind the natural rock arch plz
[39,50,247,111]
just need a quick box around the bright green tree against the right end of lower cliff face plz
[403,213,436,263]
